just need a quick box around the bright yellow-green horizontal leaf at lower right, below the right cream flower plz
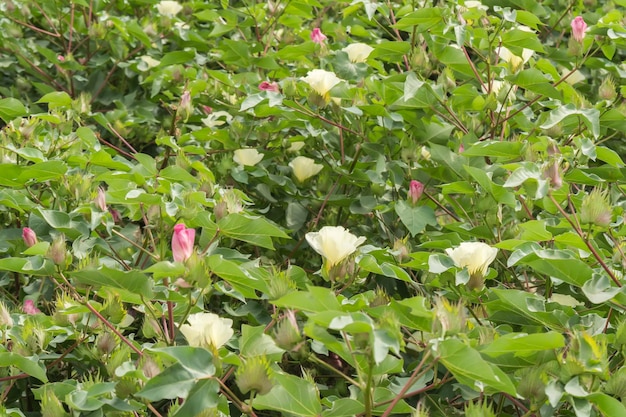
[480,332,565,357]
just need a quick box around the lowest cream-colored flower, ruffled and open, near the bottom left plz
[180,313,234,349]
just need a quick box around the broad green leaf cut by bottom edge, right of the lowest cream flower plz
[253,374,322,417]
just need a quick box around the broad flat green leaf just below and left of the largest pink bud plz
[70,266,154,298]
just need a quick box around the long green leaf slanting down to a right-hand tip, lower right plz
[432,339,516,395]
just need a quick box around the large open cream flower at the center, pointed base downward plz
[306,226,365,268]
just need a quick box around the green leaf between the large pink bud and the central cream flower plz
[217,213,289,249]
